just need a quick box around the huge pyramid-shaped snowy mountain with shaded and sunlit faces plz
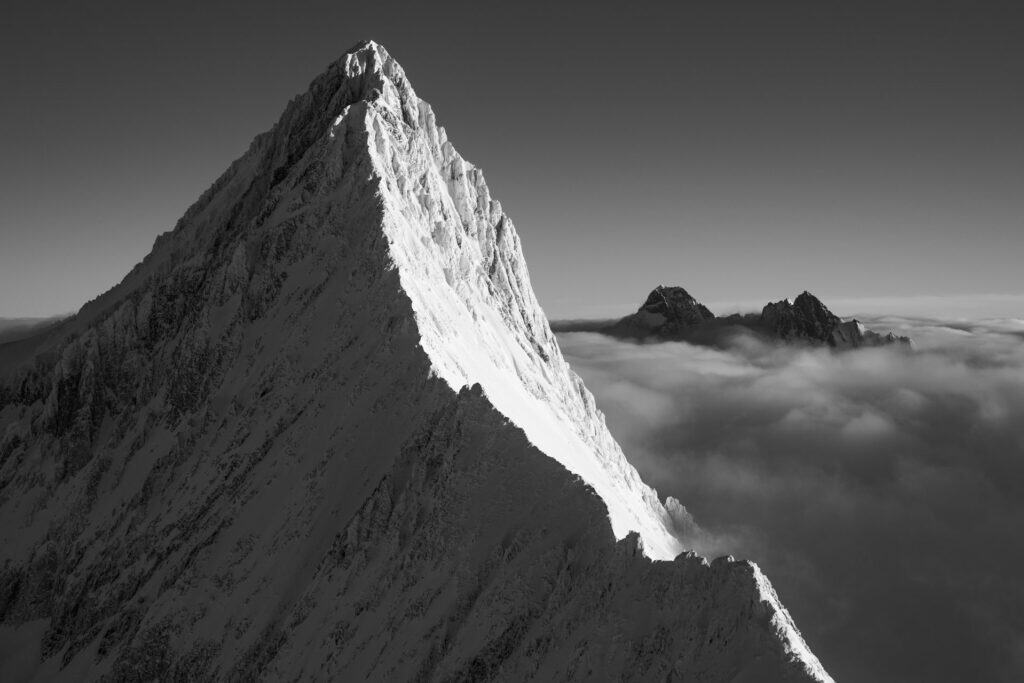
[0,42,829,682]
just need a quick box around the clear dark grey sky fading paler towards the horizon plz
[0,0,1024,317]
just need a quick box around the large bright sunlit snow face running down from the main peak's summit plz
[335,43,682,560]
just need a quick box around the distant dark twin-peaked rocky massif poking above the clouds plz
[598,285,911,349]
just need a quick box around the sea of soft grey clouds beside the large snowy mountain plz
[559,317,1024,681]
